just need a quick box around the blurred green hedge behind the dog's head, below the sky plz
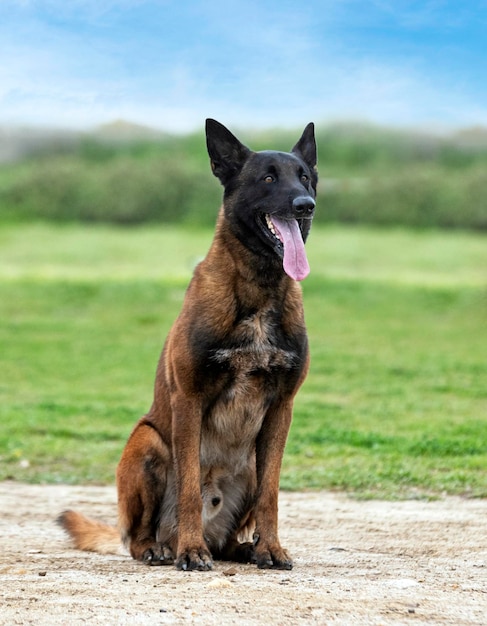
[0,125,487,230]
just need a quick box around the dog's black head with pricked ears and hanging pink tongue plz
[206,119,318,280]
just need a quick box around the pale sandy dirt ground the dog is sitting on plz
[0,482,487,626]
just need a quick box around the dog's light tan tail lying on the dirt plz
[57,511,126,554]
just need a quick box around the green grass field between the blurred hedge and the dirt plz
[0,225,487,498]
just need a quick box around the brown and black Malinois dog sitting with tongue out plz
[58,119,318,571]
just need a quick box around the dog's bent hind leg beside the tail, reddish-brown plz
[117,420,176,565]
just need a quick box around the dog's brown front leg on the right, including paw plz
[254,401,293,569]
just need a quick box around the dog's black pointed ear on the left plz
[206,118,251,185]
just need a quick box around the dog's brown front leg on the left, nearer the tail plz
[171,392,213,570]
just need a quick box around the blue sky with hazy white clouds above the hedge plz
[0,0,487,132]
